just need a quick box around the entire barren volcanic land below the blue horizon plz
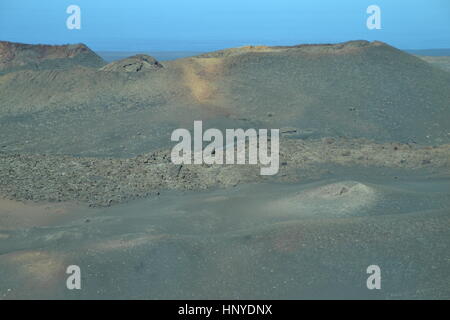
[0,41,450,299]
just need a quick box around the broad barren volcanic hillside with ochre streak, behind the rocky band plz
[0,41,450,156]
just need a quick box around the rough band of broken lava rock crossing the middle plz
[0,138,450,206]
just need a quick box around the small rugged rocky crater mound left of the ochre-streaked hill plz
[100,54,163,72]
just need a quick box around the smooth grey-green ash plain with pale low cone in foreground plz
[0,174,450,299]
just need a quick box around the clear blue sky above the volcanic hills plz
[0,0,450,51]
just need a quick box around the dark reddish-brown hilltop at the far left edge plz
[0,41,105,73]
